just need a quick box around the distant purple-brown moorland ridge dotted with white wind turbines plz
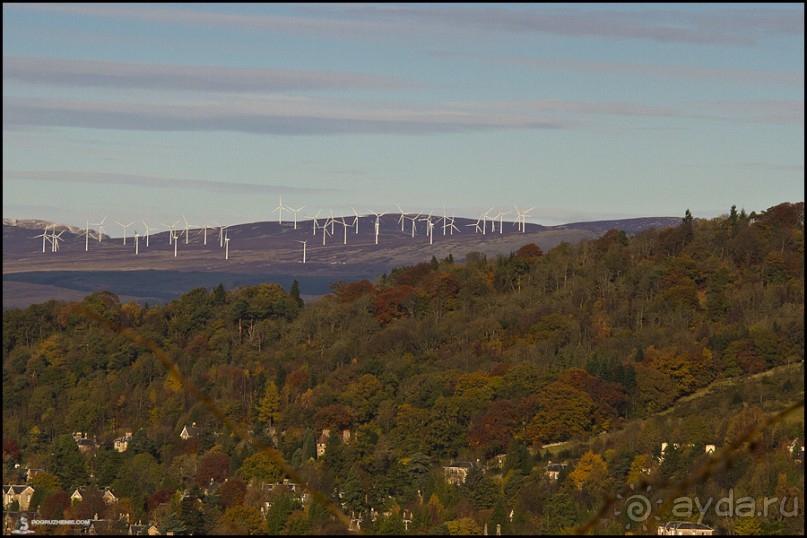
[3,214,681,309]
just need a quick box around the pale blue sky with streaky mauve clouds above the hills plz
[3,3,804,230]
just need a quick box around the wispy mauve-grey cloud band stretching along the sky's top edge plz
[11,4,804,45]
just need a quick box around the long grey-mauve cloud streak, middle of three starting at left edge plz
[3,96,566,135]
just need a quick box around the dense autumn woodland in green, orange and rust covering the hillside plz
[3,203,805,534]
